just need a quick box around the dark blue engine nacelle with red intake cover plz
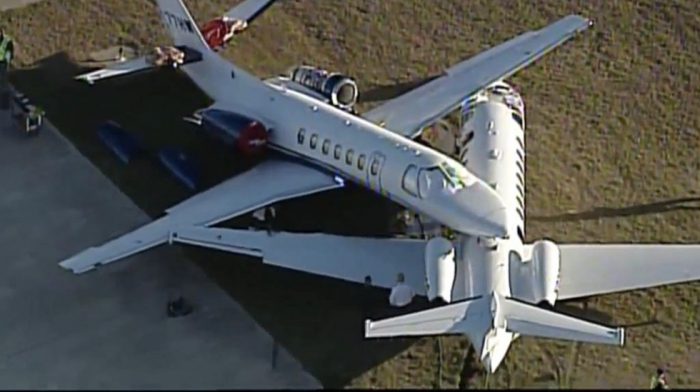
[195,109,269,156]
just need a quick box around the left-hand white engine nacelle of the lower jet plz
[425,237,457,303]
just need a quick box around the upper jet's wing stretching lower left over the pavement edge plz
[60,160,342,274]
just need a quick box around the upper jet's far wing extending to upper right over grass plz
[364,15,592,138]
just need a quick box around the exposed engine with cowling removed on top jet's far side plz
[289,65,359,110]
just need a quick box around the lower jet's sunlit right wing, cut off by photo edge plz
[544,244,700,300]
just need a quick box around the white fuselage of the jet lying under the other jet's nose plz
[453,83,525,369]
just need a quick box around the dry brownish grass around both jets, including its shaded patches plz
[2,0,700,388]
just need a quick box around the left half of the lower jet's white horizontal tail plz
[365,297,489,338]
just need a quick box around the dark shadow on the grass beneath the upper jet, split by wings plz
[10,53,415,388]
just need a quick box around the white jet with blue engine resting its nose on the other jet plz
[60,0,589,273]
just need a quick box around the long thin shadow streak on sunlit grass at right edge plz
[529,197,700,222]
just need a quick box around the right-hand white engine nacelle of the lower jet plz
[530,240,561,306]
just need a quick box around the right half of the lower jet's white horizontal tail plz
[501,299,625,346]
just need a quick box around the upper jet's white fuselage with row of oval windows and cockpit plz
[182,52,510,237]
